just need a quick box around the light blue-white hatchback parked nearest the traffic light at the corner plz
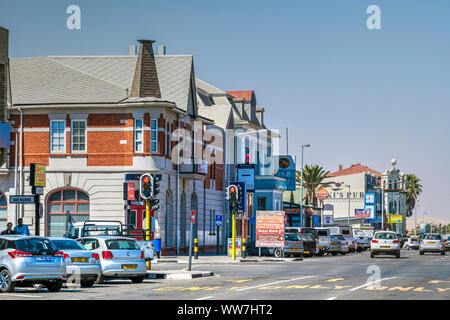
[78,236,147,283]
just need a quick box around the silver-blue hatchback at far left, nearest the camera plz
[0,235,67,293]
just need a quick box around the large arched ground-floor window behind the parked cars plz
[47,189,90,237]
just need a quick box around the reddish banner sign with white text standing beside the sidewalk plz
[256,210,285,248]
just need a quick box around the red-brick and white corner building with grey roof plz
[0,40,224,254]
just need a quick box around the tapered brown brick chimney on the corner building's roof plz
[130,40,161,98]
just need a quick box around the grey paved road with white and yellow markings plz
[1,251,450,300]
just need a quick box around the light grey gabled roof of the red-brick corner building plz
[11,55,193,110]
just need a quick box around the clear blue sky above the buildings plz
[0,0,450,220]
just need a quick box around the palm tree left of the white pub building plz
[296,165,334,206]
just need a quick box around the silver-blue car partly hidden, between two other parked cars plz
[49,238,102,288]
